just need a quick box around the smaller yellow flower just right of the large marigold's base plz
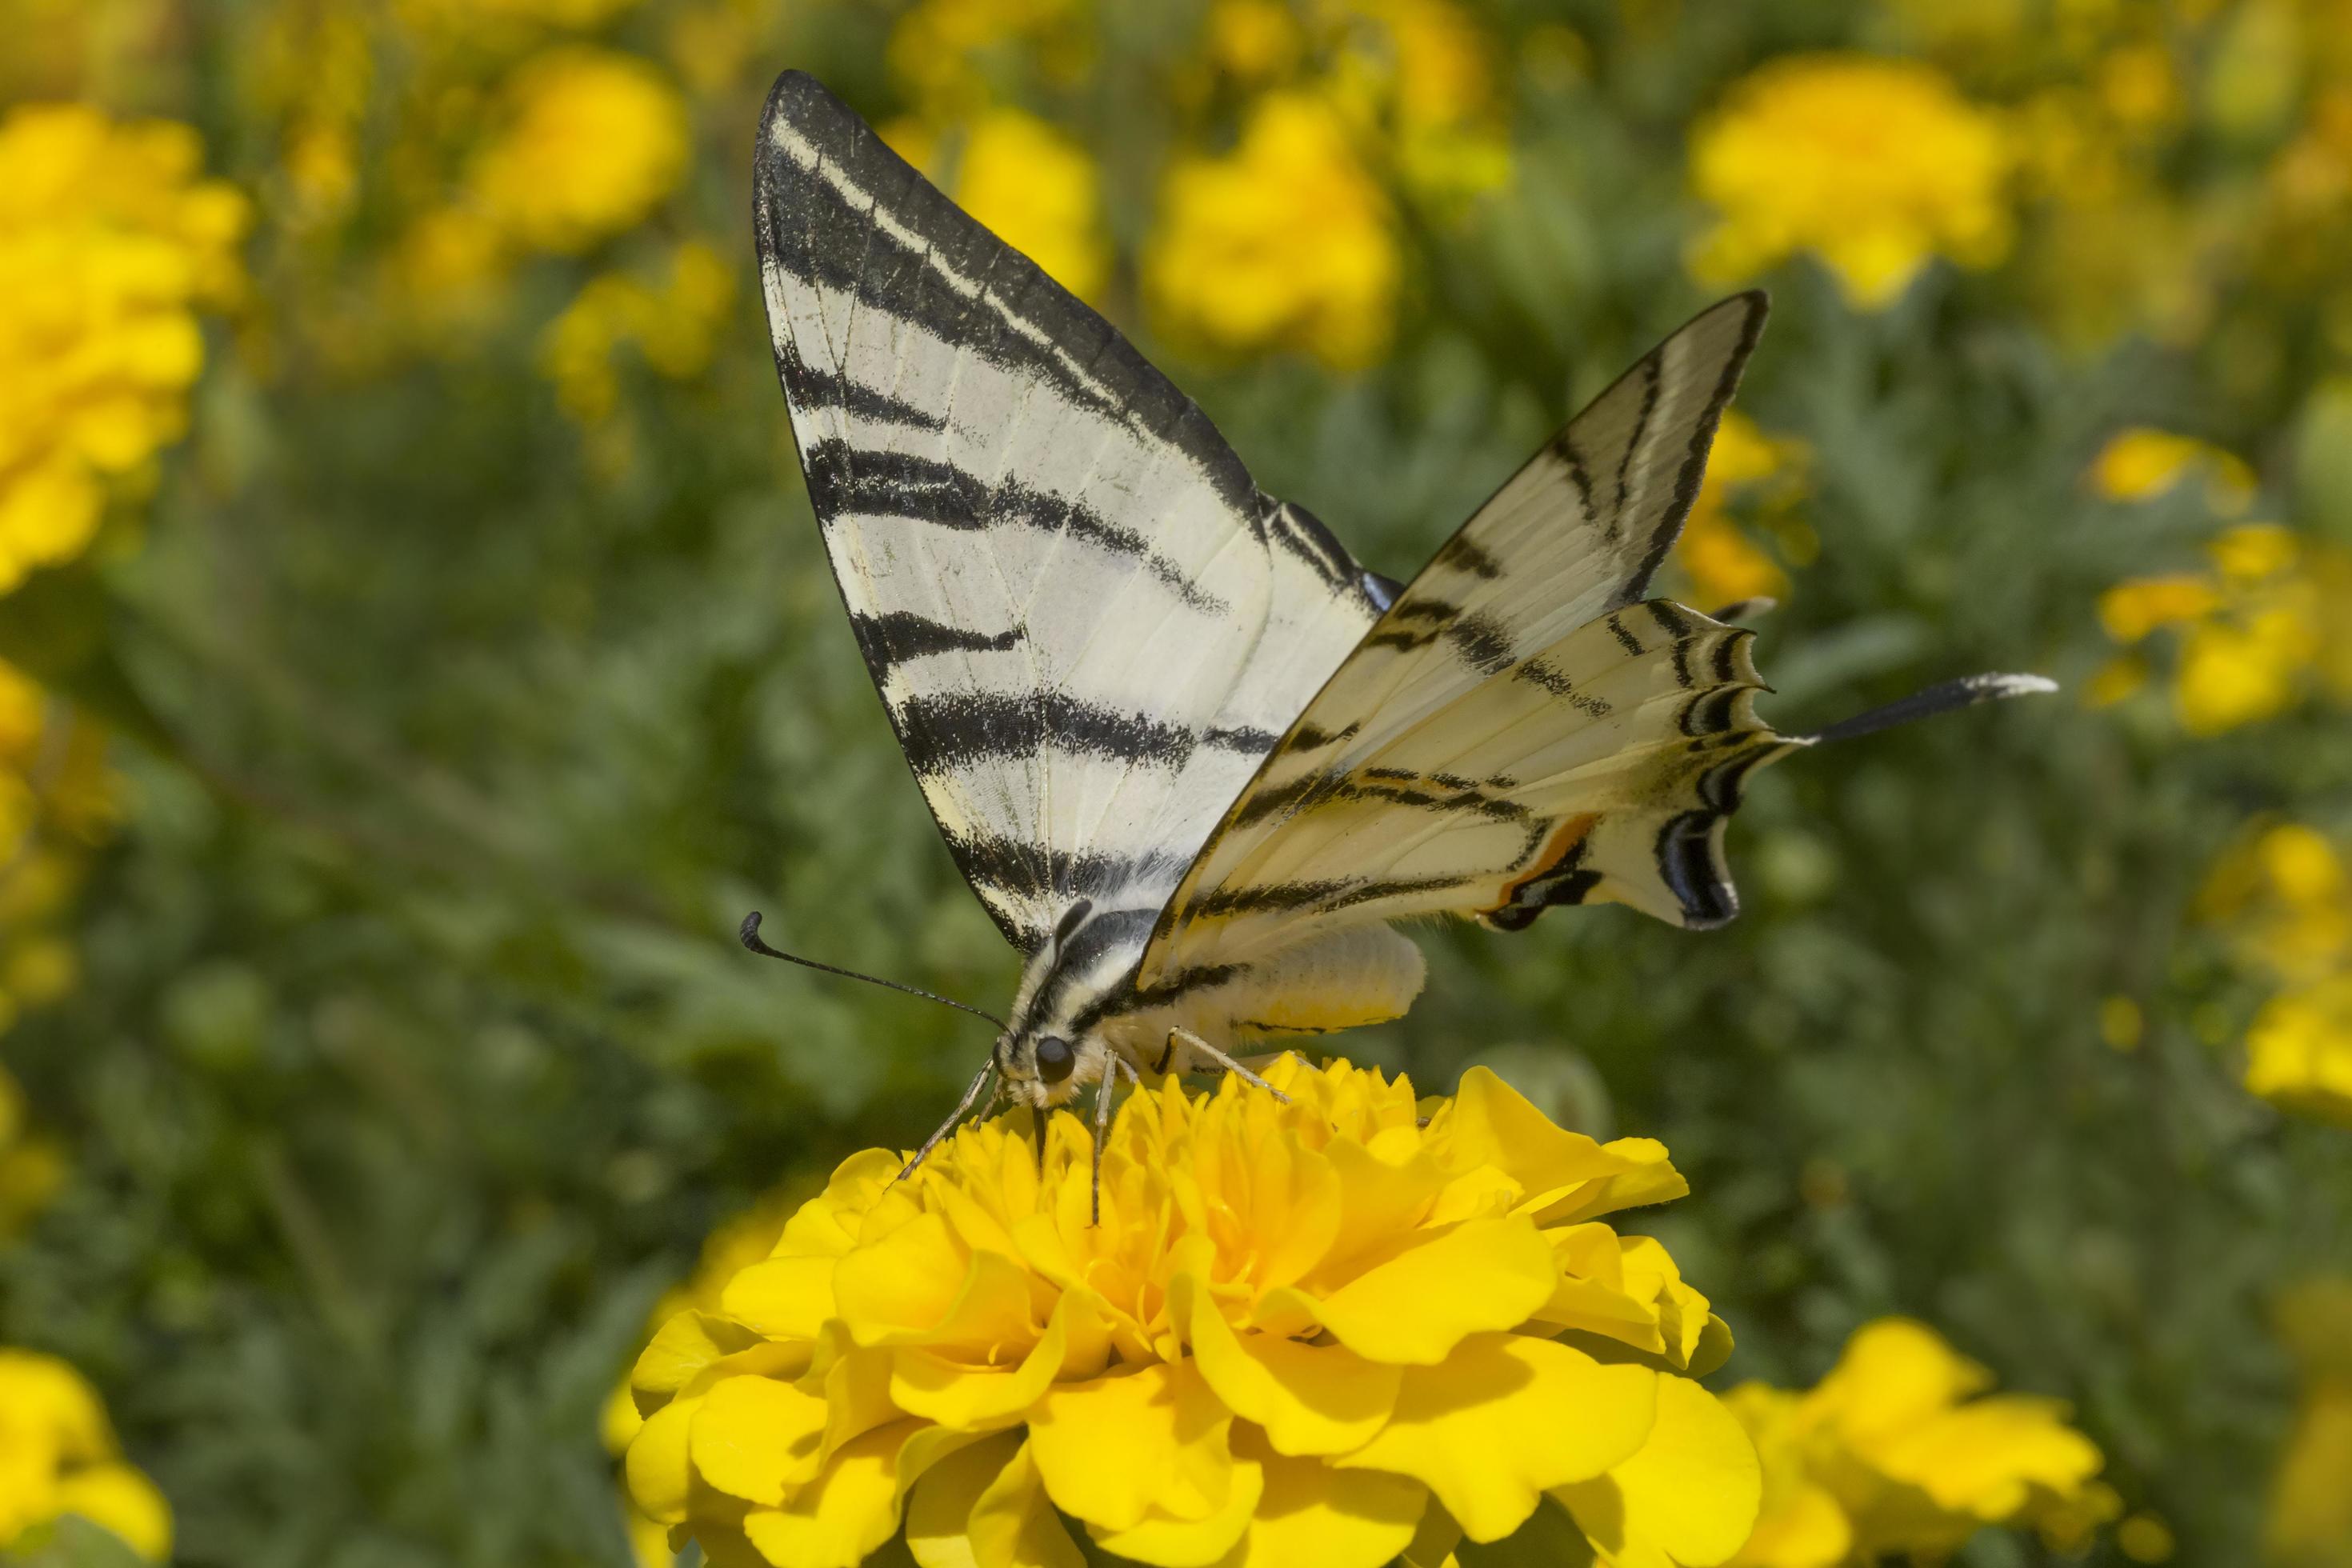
[1724,1319,2119,1568]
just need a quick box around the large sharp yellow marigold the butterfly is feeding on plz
[628,1055,1757,1568]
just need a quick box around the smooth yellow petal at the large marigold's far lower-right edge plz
[1552,1378,1764,1568]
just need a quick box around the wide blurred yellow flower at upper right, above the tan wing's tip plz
[1691,54,2014,310]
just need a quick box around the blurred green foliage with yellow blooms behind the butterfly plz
[0,0,2352,1568]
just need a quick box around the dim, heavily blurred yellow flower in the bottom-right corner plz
[2262,1279,2352,1568]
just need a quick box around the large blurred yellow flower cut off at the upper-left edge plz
[0,103,247,594]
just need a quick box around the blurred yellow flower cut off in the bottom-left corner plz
[0,1350,172,1561]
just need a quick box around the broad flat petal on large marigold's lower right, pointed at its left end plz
[1331,1333,1658,1542]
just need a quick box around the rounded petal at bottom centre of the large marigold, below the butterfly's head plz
[1030,1361,1233,1530]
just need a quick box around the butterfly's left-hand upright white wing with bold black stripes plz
[755,73,1378,964]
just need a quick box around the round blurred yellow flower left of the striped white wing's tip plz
[470,47,686,251]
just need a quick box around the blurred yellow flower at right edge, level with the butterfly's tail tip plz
[2098,522,2352,736]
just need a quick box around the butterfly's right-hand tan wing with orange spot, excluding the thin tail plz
[1141,296,1802,985]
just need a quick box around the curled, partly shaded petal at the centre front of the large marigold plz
[1171,1274,1404,1455]
